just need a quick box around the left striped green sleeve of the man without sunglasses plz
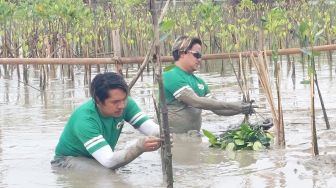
[74,118,108,155]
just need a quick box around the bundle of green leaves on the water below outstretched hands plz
[202,123,273,151]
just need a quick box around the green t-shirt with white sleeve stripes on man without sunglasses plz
[55,97,148,157]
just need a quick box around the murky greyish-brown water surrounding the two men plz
[0,59,336,188]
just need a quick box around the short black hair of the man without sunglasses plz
[90,72,129,103]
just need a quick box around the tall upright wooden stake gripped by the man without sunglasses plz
[149,0,174,188]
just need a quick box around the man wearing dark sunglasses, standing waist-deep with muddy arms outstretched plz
[163,36,254,133]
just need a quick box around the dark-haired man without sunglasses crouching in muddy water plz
[51,72,161,169]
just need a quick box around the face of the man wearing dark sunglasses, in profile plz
[184,44,202,72]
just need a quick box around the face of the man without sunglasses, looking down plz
[97,89,127,117]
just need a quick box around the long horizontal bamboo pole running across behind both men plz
[0,44,336,65]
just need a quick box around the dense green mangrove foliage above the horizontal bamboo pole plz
[0,0,336,57]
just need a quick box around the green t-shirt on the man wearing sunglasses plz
[163,66,210,105]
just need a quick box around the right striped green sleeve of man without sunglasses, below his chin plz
[124,97,149,128]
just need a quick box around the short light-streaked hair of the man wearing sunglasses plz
[172,35,202,61]
